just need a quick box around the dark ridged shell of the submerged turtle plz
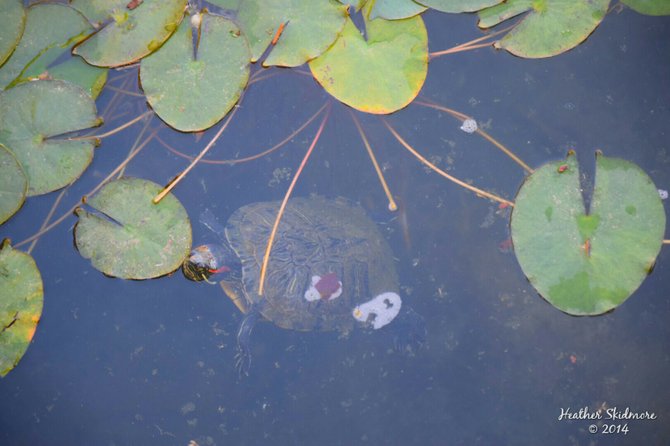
[225,196,398,332]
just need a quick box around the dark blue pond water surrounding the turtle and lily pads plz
[0,6,670,446]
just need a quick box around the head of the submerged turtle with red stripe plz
[182,240,242,282]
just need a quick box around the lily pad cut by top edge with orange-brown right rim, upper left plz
[73,0,186,67]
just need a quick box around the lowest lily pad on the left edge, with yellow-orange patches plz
[0,240,44,377]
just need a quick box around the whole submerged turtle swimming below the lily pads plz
[182,195,426,375]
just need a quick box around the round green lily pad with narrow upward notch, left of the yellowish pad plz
[140,13,251,132]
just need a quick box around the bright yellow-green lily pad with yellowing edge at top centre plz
[309,7,428,113]
